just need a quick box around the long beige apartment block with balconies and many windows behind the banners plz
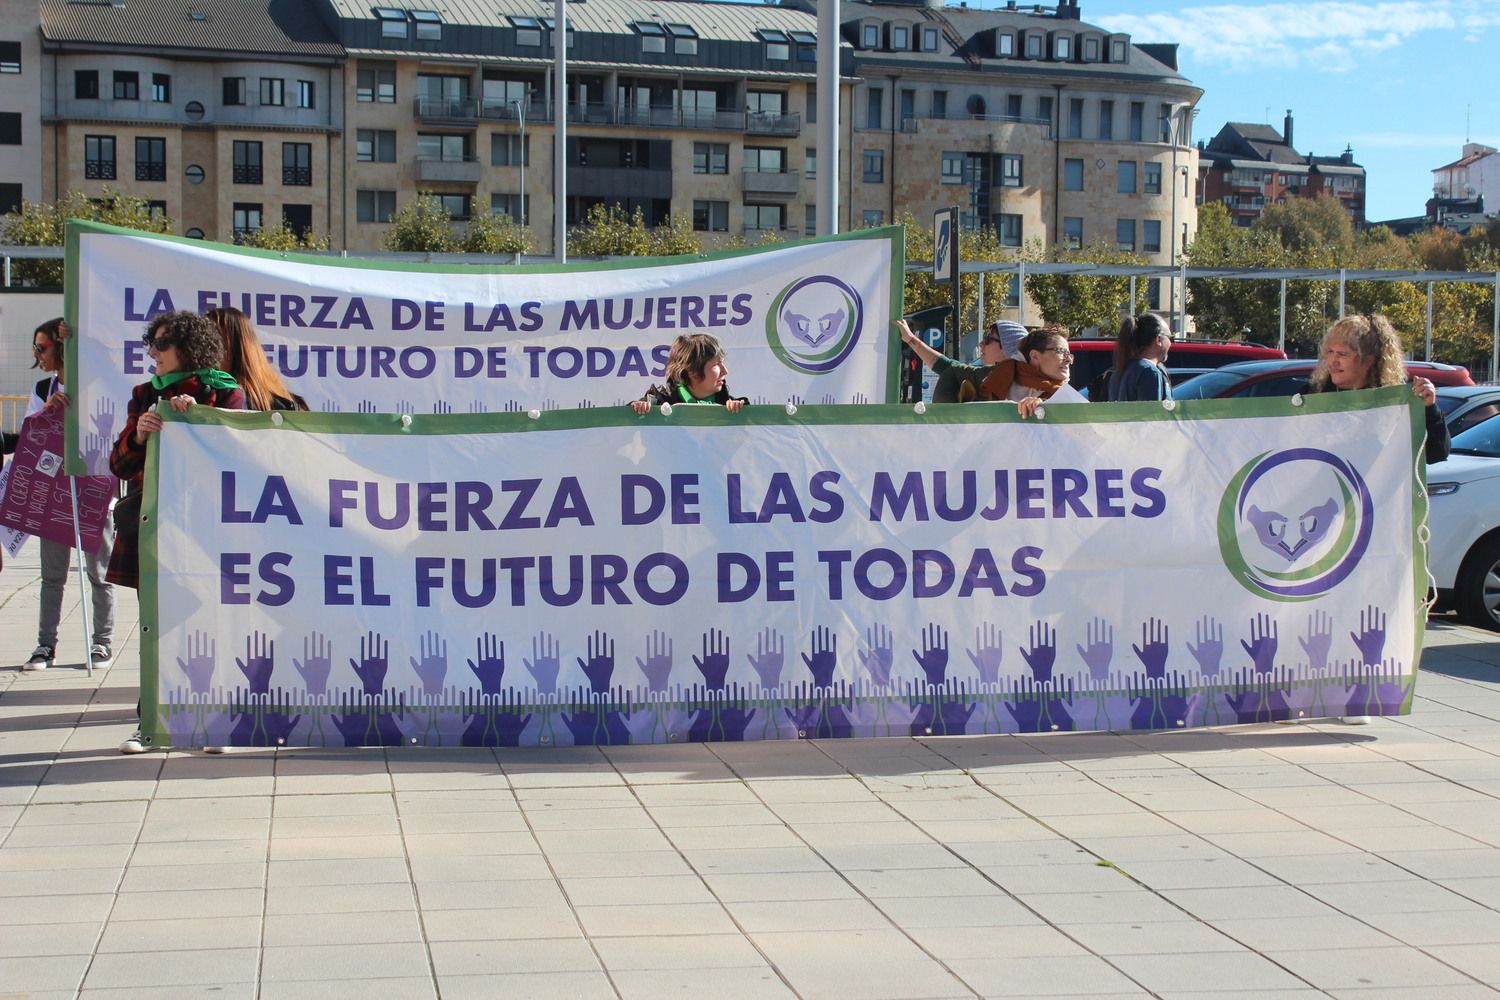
[20,0,1202,295]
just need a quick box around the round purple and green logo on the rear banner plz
[765,274,864,375]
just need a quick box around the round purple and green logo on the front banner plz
[1218,448,1376,601]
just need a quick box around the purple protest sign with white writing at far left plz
[0,406,116,555]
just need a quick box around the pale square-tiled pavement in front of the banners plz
[0,546,1500,1000]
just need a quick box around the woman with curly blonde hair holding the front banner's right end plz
[1307,313,1451,462]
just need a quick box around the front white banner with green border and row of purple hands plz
[141,387,1425,747]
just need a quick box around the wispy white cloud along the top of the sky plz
[1095,0,1500,72]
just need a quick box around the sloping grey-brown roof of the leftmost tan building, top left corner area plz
[41,0,344,58]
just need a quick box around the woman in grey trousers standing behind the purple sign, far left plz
[5,316,114,670]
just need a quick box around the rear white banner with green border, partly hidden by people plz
[66,222,905,472]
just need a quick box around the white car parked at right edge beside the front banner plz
[1427,420,1500,631]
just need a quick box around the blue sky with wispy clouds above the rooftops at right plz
[1074,0,1500,220]
